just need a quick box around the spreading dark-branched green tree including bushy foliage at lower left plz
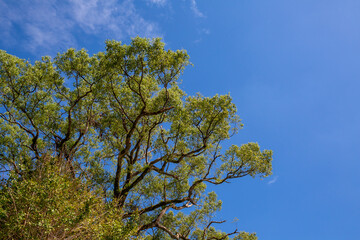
[0,38,272,240]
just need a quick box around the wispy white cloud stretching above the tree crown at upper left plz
[0,0,160,52]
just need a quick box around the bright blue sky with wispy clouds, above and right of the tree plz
[0,0,360,240]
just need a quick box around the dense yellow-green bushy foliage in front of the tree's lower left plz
[0,158,136,239]
